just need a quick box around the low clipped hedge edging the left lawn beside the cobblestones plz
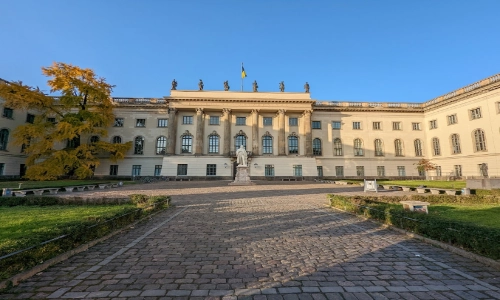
[0,195,170,280]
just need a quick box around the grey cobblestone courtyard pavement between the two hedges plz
[0,182,500,299]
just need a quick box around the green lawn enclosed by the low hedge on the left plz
[0,204,135,255]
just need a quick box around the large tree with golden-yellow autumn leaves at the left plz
[0,63,132,180]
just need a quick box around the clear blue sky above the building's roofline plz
[0,0,500,102]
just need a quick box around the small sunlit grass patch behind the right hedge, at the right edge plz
[428,204,500,229]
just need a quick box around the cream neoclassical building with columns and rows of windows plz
[0,74,500,180]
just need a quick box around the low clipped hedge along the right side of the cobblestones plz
[328,195,500,259]
